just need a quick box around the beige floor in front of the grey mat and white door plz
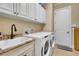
[53,47,79,56]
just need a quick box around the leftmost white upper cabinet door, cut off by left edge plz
[0,3,13,13]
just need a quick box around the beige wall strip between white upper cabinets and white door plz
[43,3,54,32]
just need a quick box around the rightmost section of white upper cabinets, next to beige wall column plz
[36,4,46,23]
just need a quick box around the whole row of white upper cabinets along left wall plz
[0,3,46,23]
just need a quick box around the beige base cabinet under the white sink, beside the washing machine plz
[0,41,35,56]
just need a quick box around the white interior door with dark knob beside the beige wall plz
[54,6,72,50]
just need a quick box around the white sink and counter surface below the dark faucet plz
[0,37,32,50]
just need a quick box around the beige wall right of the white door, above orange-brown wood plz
[72,3,79,27]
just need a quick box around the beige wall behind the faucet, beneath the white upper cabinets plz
[0,17,43,34]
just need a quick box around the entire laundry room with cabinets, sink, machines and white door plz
[0,3,79,56]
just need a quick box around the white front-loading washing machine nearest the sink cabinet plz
[25,32,52,56]
